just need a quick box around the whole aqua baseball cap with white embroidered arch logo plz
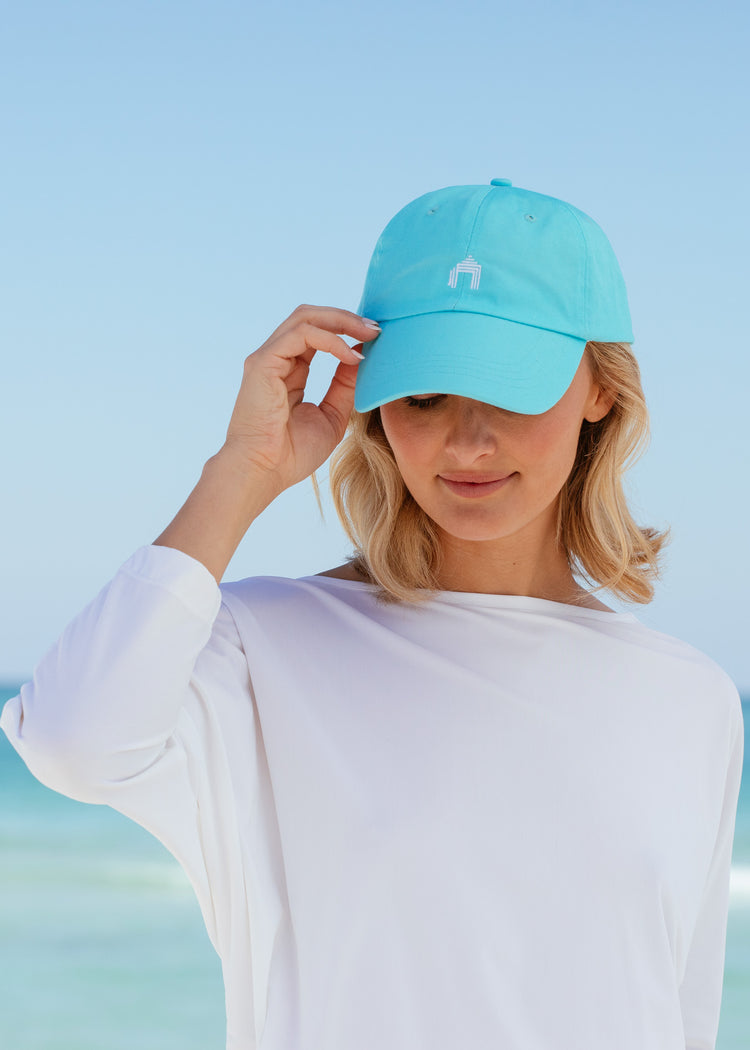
[354,179,632,414]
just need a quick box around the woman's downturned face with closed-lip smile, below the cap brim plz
[380,355,611,541]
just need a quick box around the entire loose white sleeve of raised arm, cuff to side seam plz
[1,546,262,952]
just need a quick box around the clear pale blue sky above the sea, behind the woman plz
[0,0,750,694]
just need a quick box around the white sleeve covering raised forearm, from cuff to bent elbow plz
[1,547,221,802]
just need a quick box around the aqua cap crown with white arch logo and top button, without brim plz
[359,180,632,342]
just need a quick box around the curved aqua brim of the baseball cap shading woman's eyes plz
[354,311,586,415]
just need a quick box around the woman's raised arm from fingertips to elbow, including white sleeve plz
[2,307,376,800]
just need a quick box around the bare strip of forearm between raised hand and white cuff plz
[154,449,277,583]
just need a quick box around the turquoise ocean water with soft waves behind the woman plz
[0,688,750,1050]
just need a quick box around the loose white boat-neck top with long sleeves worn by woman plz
[1,547,743,1050]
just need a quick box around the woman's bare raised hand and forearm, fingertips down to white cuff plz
[154,307,379,581]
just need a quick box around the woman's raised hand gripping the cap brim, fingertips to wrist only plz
[220,306,379,494]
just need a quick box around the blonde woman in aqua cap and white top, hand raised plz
[2,180,743,1050]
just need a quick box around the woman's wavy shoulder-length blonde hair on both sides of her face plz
[330,342,668,604]
